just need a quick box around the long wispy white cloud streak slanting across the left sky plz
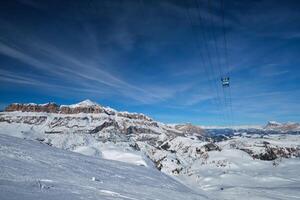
[0,24,195,103]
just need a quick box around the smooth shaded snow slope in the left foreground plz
[0,135,206,200]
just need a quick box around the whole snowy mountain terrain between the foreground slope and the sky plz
[0,100,300,199]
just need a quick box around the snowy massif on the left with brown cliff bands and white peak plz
[0,100,190,169]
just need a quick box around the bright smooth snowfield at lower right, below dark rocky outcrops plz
[180,149,300,200]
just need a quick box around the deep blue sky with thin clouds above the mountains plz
[0,0,300,125]
